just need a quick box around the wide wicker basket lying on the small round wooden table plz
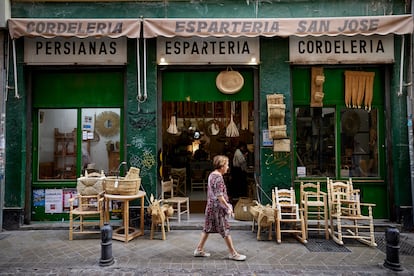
[104,176,141,195]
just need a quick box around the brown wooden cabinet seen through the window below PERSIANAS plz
[54,128,76,179]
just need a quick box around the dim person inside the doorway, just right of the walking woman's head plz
[231,142,248,198]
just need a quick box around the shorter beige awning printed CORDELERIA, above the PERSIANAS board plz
[8,18,141,39]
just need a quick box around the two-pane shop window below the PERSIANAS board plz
[38,108,120,180]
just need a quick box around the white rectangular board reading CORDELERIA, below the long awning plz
[289,35,394,64]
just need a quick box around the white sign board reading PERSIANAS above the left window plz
[24,37,127,65]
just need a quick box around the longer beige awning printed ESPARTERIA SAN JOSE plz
[143,14,413,38]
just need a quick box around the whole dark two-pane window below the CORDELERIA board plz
[295,107,378,177]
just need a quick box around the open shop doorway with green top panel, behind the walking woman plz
[161,70,255,213]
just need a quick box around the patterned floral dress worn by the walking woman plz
[203,172,230,238]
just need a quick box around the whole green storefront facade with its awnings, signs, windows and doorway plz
[4,1,413,229]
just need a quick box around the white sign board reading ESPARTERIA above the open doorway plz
[157,37,260,64]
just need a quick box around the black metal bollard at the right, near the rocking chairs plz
[384,227,403,271]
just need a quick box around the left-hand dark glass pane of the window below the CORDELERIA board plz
[295,107,335,177]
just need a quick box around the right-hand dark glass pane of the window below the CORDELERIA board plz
[341,108,378,177]
